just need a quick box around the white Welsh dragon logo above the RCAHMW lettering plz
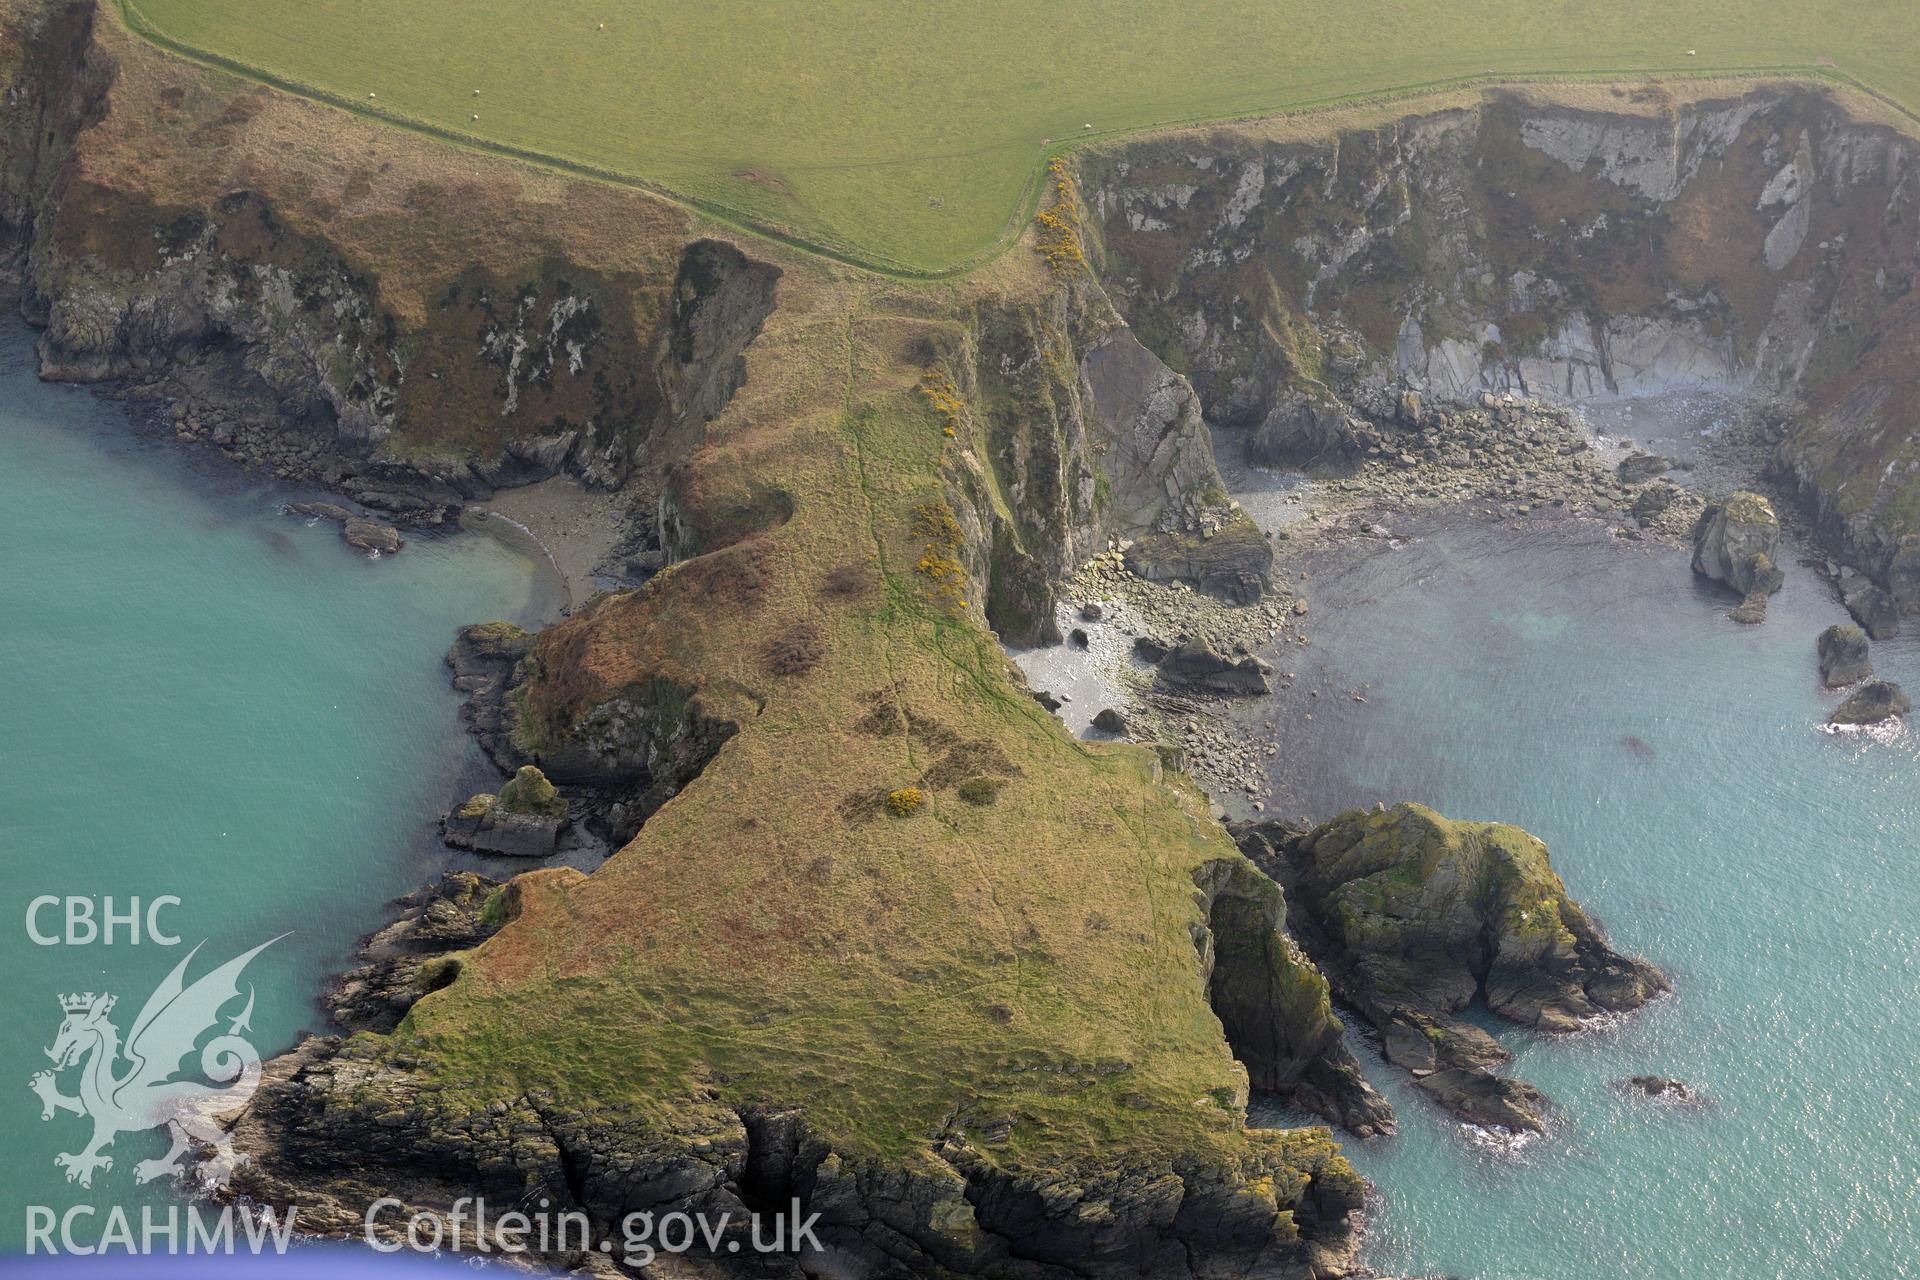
[29,933,286,1186]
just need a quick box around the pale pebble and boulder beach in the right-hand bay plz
[1023,385,1774,819]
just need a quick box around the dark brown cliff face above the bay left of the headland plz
[0,0,780,522]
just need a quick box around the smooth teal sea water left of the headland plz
[0,322,555,1255]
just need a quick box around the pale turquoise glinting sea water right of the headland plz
[1256,522,1920,1280]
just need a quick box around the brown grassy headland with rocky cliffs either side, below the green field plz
[0,0,1920,1278]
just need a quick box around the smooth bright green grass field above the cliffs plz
[123,0,1920,273]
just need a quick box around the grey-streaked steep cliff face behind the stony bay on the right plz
[1081,88,1920,612]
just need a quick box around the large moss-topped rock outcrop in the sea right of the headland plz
[1242,804,1667,1128]
